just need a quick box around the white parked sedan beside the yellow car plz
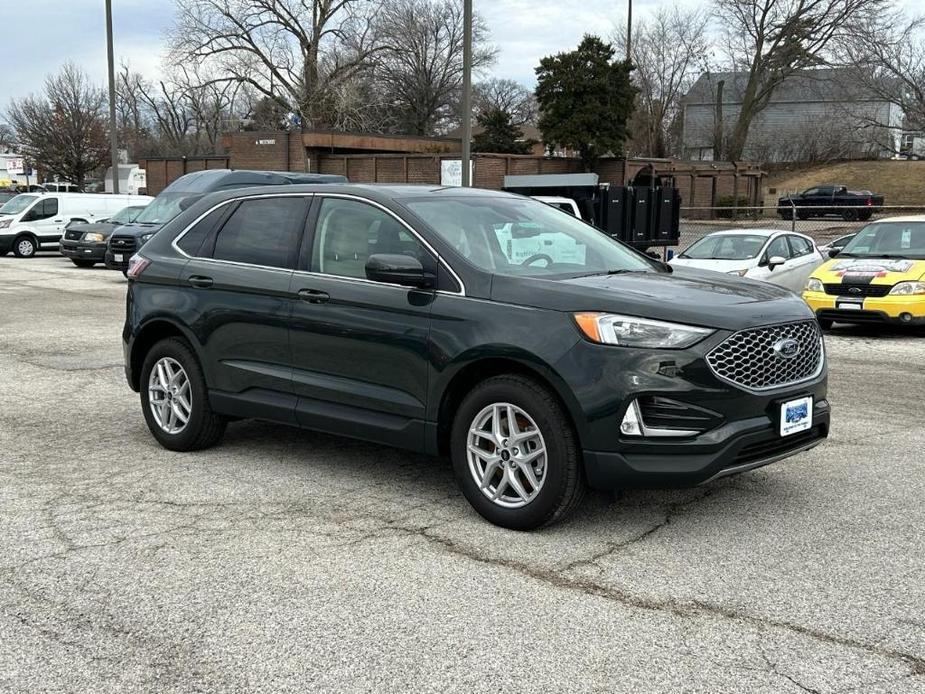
[670,229,826,292]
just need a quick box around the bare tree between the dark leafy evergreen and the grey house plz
[613,6,710,157]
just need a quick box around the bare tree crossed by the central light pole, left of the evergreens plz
[374,0,495,135]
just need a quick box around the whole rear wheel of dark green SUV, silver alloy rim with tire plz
[141,338,227,451]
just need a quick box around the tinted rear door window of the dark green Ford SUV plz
[212,197,305,268]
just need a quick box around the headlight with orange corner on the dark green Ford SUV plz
[575,313,714,349]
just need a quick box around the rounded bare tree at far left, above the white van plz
[7,63,110,189]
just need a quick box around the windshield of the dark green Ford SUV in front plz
[403,196,657,278]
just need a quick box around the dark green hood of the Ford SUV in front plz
[491,268,813,330]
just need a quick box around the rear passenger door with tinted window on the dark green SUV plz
[177,195,311,423]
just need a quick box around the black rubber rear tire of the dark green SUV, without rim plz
[140,337,228,451]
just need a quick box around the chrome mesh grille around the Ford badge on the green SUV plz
[707,320,823,390]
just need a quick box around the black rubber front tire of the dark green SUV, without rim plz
[450,374,586,530]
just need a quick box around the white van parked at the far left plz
[0,193,154,258]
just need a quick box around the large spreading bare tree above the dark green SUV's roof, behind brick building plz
[171,0,376,128]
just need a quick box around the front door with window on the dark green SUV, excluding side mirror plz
[291,196,436,449]
